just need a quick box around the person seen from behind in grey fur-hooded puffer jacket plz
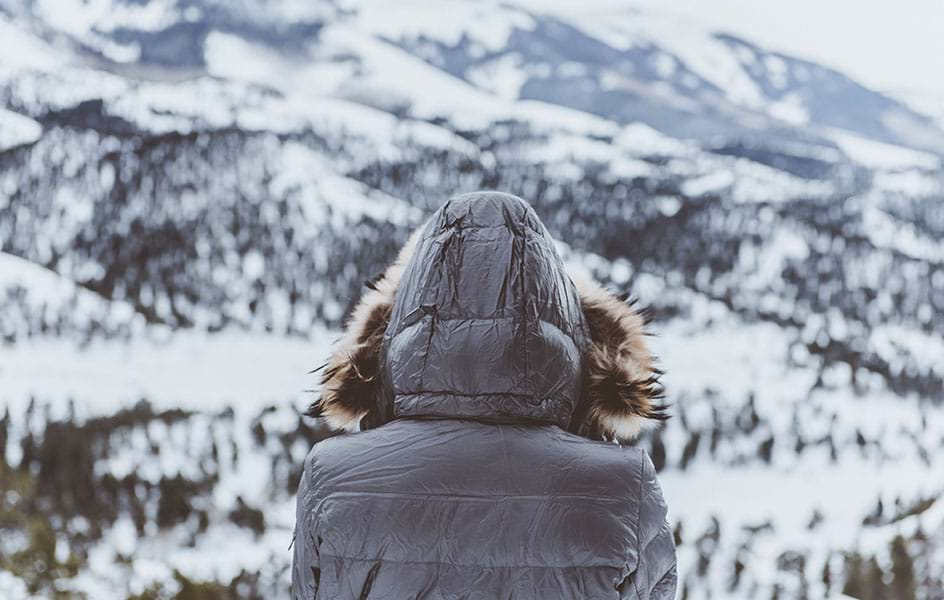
[292,192,677,600]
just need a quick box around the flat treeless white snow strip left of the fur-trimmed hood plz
[0,330,328,416]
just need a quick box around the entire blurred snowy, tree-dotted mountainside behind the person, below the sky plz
[0,0,944,599]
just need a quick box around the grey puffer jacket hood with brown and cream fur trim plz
[309,192,667,441]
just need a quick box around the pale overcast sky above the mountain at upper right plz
[528,0,944,93]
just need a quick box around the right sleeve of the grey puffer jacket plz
[623,452,678,600]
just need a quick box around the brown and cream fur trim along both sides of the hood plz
[308,218,668,441]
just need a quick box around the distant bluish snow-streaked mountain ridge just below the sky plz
[4,0,944,155]
